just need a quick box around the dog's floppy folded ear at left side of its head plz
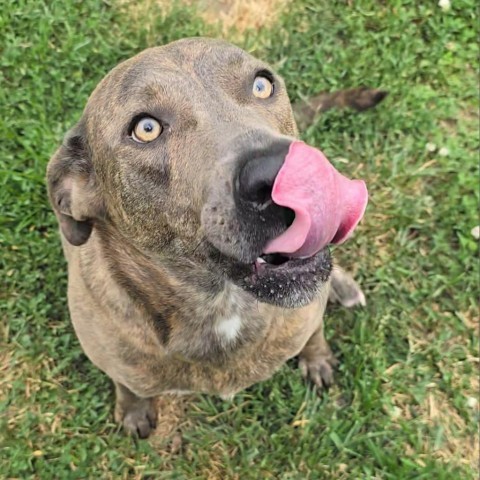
[47,123,104,246]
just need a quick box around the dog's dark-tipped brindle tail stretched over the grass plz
[293,87,388,130]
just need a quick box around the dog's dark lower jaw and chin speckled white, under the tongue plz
[210,247,332,308]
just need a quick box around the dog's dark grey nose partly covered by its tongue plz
[236,141,291,208]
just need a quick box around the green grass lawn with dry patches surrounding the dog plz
[0,0,479,480]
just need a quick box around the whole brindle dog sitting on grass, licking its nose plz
[47,38,383,438]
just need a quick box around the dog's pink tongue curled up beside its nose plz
[264,142,368,257]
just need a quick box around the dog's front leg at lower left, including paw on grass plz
[115,382,157,438]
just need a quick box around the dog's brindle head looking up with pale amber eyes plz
[47,38,366,307]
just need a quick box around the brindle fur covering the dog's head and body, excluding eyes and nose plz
[47,39,382,437]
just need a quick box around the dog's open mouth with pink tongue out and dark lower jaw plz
[202,141,368,308]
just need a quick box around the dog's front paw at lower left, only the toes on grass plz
[115,399,157,438]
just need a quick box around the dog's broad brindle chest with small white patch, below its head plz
[69,255,328,397]
